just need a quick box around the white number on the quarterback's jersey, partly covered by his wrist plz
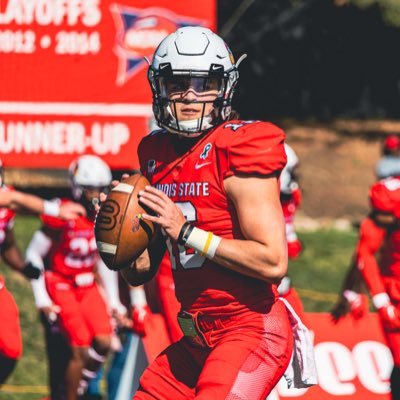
[166,201,205,269]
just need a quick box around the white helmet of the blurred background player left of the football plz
[69,155,112,200]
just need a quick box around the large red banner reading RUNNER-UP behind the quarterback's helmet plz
[0,0,216,169]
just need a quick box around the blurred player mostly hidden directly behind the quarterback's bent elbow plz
[278,143,305,322]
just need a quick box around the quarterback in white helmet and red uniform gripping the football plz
[122,27,293,400]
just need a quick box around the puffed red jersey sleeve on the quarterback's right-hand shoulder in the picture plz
[216,121,286,179]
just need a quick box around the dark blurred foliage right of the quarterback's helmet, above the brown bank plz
[218,0,400,120]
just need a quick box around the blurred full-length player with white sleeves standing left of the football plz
[26,155,122,400]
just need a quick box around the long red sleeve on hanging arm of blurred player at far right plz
[356,218,386,296]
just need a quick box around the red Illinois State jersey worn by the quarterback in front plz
[138,121,286,314]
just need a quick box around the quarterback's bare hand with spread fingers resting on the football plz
[139,186,186,241]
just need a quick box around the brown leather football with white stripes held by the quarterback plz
[94,174,156,270]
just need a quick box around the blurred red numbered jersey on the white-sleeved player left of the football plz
[41,201,99,277]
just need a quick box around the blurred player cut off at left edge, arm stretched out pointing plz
[0,160,85,385]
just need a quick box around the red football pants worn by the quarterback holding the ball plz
[134,301,293,400]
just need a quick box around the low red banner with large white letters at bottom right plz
[268,313,393,400]
